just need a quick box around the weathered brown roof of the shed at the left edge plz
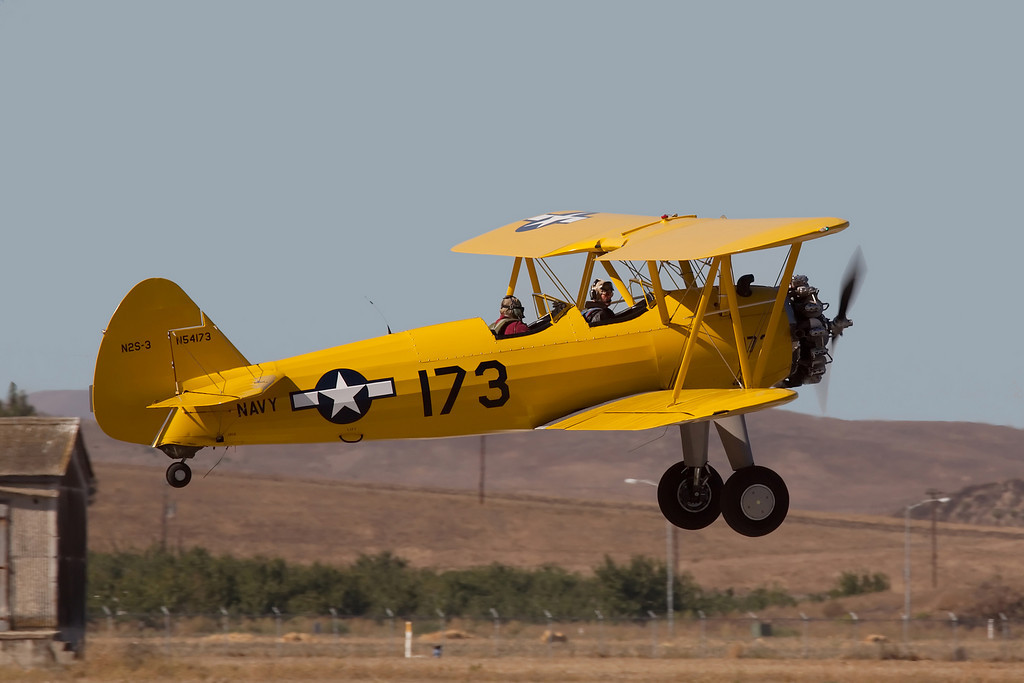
[0,418,80,476]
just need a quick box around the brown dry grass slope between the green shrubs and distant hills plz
[90,463,1024,618]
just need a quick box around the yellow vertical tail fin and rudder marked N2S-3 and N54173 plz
[92,279,249,445]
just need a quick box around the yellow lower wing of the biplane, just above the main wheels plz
[543,389,797,431]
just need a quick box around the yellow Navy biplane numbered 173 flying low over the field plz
[91,211,855,536]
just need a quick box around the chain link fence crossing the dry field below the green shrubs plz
[89,610,1024,661]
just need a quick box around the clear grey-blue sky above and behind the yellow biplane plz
[0,0,1024,427]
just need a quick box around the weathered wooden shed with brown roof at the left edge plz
[0,417,95,665]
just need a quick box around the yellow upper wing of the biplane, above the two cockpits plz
[452,211,849,261]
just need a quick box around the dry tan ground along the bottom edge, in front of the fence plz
[8,638,1022,683]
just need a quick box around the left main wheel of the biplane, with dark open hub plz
[657,463,722,530]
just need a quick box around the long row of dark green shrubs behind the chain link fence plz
[88,547,796,620]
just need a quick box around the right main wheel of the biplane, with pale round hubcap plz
[722,465,790,537]
